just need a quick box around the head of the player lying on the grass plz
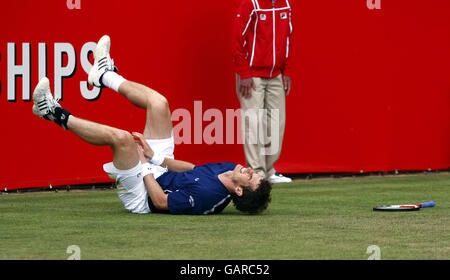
[232,165,272,214]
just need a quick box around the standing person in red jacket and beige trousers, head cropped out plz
[233,0,292,183]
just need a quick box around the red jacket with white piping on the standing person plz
[233,0,292,79]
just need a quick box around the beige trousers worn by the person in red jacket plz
[236,75,286,178]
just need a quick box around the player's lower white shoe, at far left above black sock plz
[33,77,61,121]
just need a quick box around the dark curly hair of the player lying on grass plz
[232,179,272,214]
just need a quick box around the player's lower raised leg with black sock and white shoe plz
[33,78,139,170]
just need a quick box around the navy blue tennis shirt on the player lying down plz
[149,162,236,215]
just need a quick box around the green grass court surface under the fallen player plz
[0,173,450,260]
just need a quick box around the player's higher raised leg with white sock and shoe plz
[88,35,173,139]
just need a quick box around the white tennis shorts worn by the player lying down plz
[103,136,175,214]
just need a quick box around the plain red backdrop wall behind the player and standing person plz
[0,0,450,189]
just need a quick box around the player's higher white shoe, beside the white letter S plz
[88,35,117,88]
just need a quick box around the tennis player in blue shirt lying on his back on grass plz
[33,35,271,214]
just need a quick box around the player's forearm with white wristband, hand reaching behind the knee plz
[132,132,195,172]
